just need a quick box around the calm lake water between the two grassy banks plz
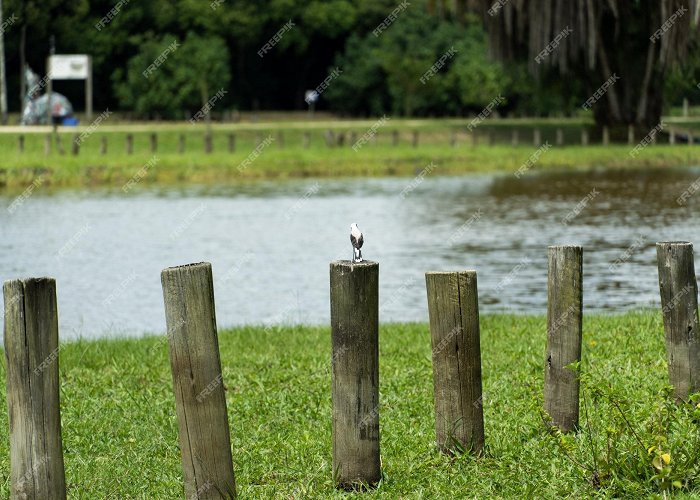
[0,169,700,339]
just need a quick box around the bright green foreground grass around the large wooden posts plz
[0,313,700,498]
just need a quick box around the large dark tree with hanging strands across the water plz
[478,0,700,128]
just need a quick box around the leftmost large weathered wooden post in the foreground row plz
[3,278,66,500]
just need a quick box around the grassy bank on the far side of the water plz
[0,120,700,192]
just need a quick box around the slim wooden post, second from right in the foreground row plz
[544,246,583,432]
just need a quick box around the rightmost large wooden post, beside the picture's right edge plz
[656,241,700,401]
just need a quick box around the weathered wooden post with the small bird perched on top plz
[330,261,381,489]
